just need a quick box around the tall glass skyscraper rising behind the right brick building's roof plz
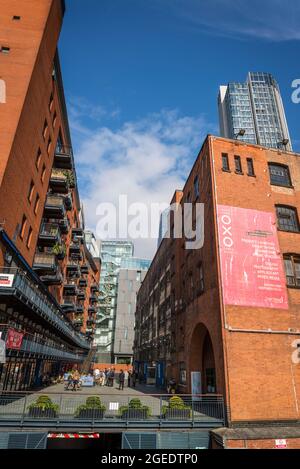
[218,72,292,151]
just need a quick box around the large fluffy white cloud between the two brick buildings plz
[71,105,215,258]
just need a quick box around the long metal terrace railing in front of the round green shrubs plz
[0,389,224,428]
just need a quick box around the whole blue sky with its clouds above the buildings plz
[60,0,300,256]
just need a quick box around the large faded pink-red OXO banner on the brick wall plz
[218,205,288,309]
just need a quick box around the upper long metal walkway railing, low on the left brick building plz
[0,268,90,349]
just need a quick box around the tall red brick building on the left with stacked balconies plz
[0,0,100,390]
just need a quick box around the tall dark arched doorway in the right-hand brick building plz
[190,323,217,394]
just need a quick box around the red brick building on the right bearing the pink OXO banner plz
[135,136,300,447]
